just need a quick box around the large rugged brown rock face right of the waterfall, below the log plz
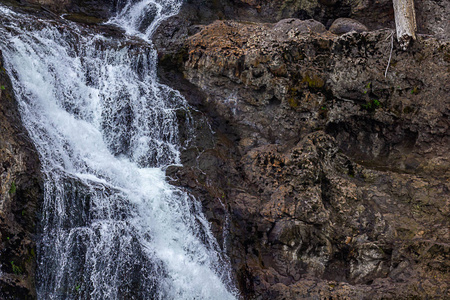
[159,12,450,299]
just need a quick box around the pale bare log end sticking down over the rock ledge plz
[392,0,417,50]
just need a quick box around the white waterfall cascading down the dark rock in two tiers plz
[0,0,238,299]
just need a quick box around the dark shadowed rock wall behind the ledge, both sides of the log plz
[154,0,450,59]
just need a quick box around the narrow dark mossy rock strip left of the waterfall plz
[0,52,42,299]
